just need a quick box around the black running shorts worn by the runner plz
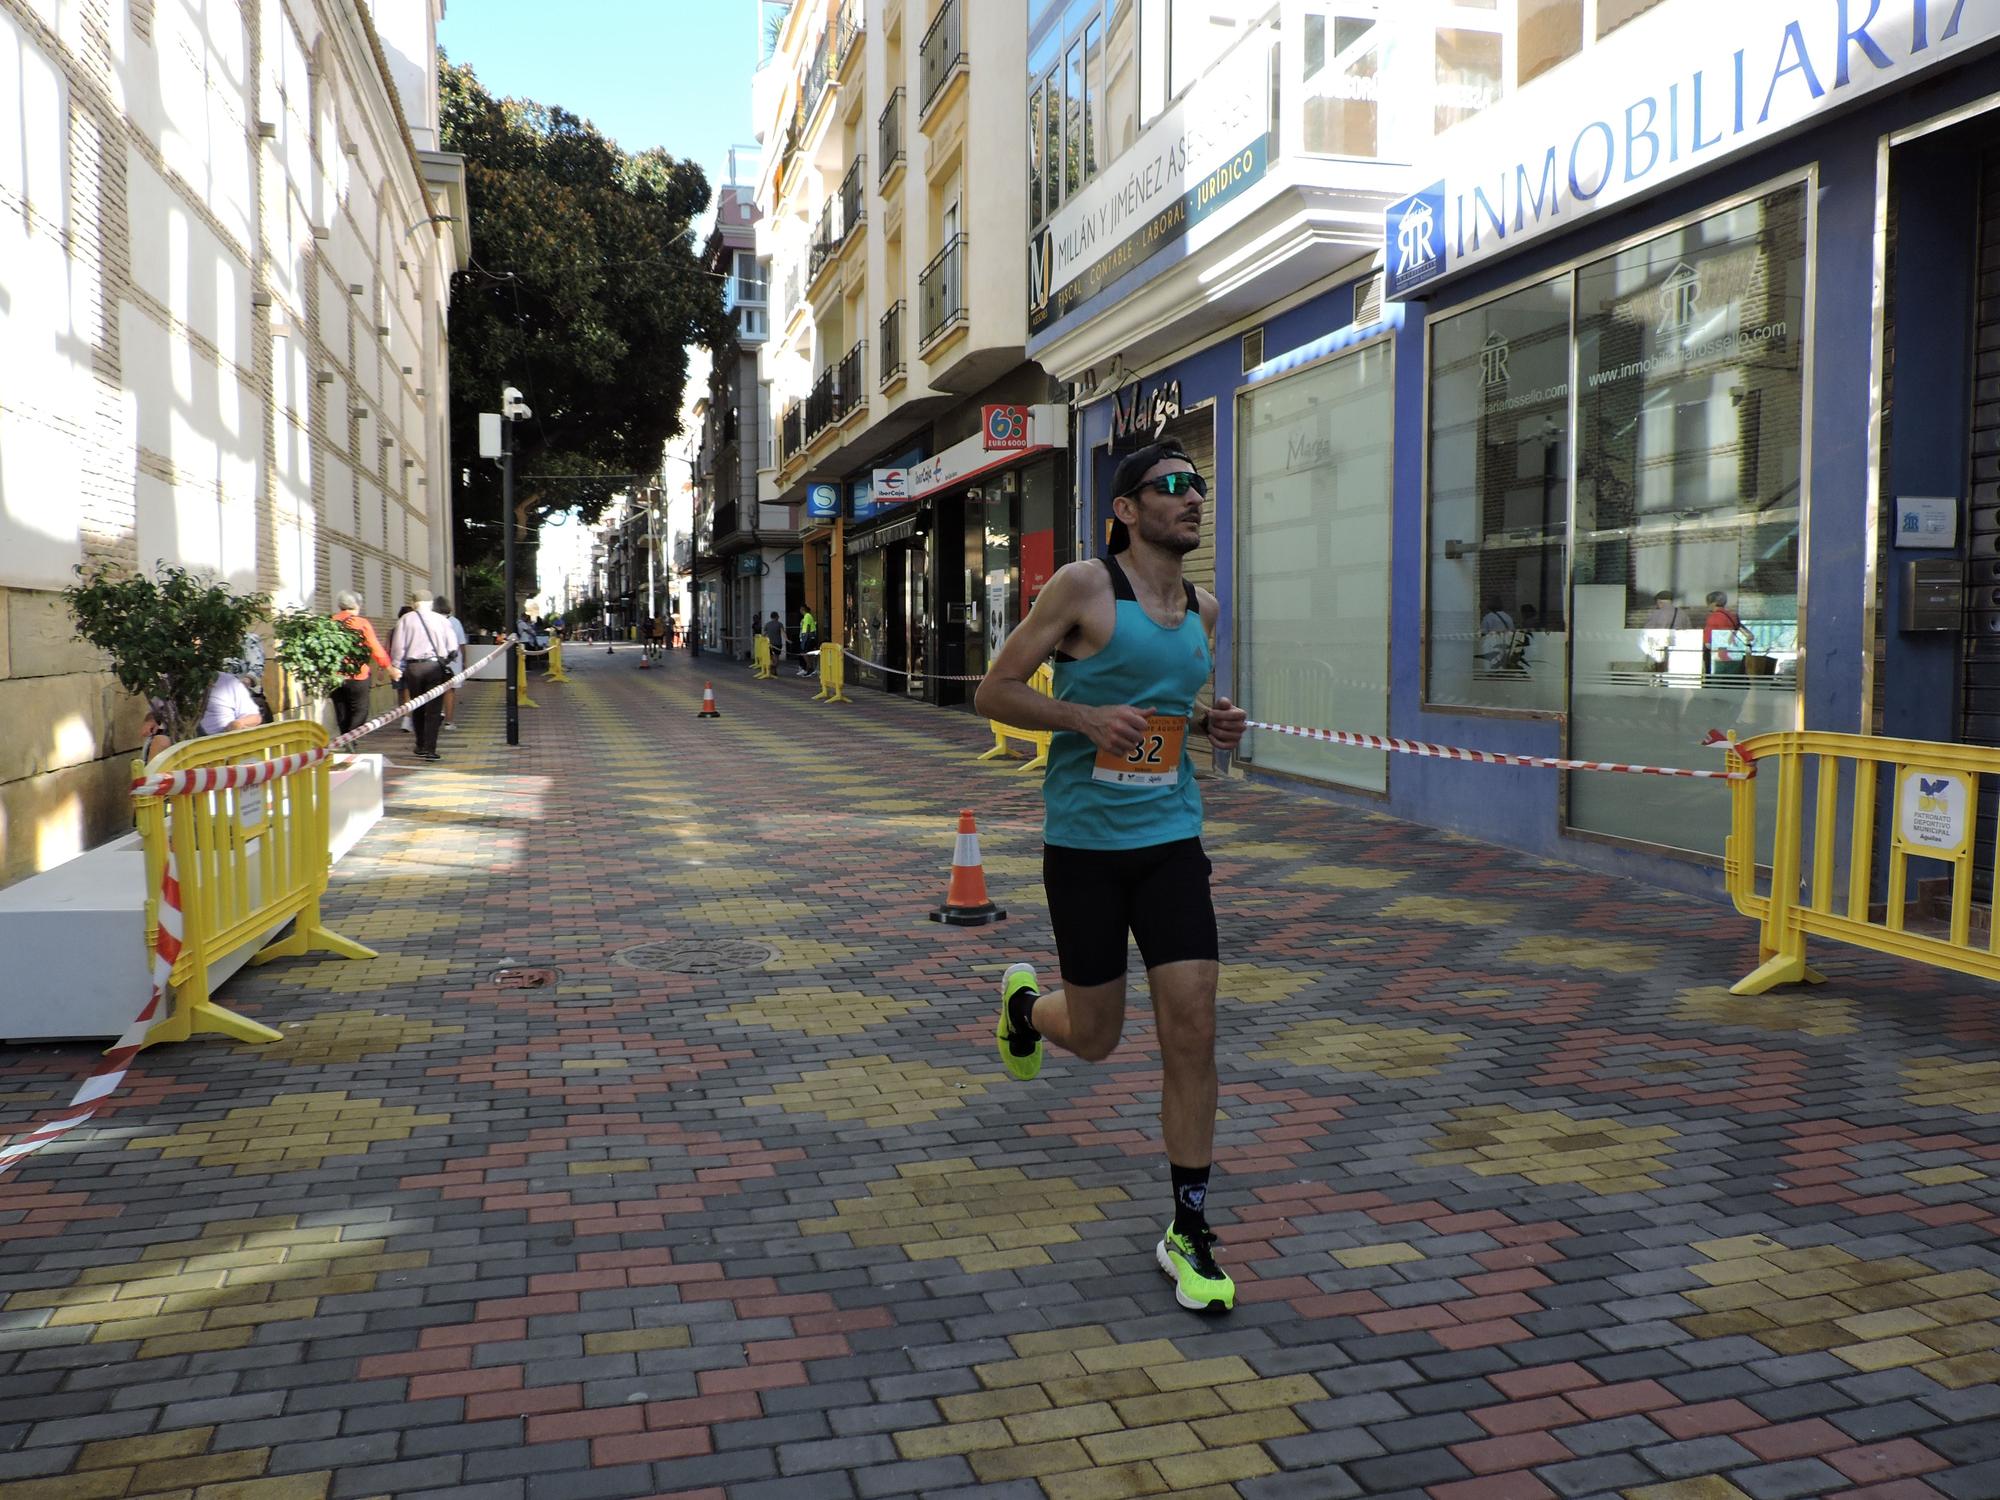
[1042,838,1218,984]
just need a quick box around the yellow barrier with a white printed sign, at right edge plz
[1724,730,2000,994]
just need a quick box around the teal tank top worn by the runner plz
[1042,556,1214,848]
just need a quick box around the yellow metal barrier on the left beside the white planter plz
[134,720,376,1046]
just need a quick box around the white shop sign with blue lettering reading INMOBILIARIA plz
[1384,0,2000,300]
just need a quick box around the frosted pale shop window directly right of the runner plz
[1236,342,1394,792]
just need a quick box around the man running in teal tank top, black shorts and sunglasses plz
[976,444,1246,1312]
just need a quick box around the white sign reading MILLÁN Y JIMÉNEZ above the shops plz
[1028,30,1272,334]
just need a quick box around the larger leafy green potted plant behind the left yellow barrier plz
[62,562,270,740]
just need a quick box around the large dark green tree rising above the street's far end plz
[438,58,730,594]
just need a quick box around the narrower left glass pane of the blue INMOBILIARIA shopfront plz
[1424,276,1570,714]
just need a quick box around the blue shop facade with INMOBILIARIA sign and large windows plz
[1030,0,2000,892]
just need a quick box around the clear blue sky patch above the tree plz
[438,0,758,194]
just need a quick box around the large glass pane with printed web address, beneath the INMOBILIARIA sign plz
[1568,186,1808,854]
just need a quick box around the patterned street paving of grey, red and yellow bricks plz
[0,648,2000,1500]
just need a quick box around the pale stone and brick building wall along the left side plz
[0,0,470,884]
